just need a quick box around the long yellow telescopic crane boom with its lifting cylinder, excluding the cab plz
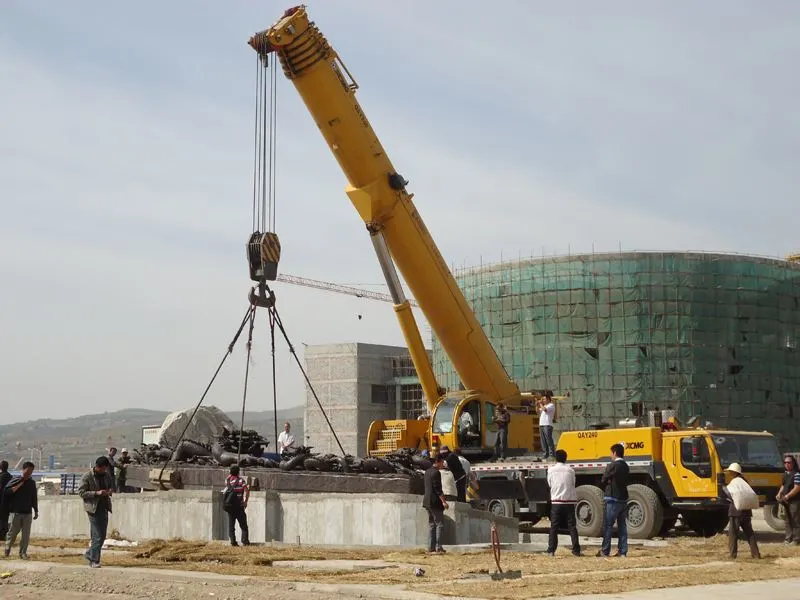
[249,6,520,418]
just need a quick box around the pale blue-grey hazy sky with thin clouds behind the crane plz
[0,0,800,423]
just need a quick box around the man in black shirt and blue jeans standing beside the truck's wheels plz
[597,444,630,557]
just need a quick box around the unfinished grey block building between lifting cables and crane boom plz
[303,343,425,455]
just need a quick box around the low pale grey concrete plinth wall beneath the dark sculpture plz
[32,490,518,546]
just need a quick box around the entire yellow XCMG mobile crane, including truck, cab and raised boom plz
[249,7,782,538]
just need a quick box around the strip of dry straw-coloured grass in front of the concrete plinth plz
[37,536,800,599]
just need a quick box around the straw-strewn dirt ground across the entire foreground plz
[0,532,800,600]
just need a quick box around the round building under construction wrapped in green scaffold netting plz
[433,252,800,449]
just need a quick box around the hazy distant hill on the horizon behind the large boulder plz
[0,406,304,469]
